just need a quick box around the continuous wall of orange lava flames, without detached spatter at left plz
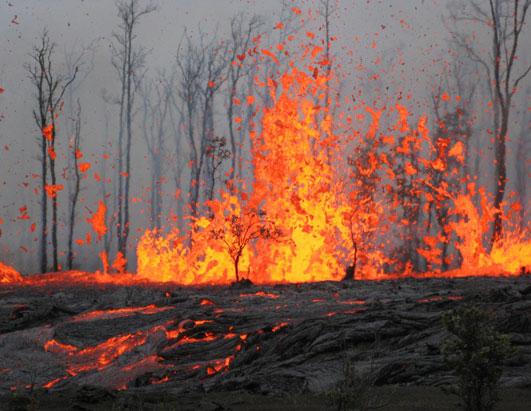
[132,37,531,284]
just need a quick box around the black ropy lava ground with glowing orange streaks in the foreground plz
[0,275,531,410]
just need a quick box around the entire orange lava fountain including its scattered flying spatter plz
[0,9,531,286]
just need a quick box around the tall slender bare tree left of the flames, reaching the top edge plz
[112,0,156,259]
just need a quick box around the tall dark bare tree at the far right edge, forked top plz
[450,0,531,247]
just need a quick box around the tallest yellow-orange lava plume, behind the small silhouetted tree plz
[137,62,356,284]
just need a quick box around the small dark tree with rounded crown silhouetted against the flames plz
[211,210,282,282]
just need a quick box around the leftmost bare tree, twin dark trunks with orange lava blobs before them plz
[26,30,77,272]
